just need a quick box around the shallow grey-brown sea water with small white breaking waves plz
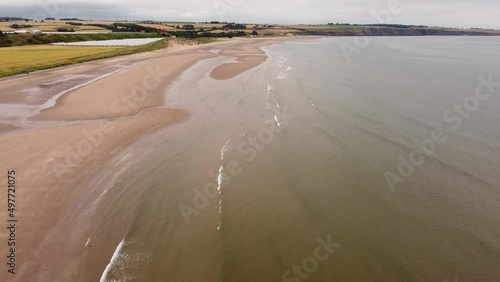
[93,37,500,282]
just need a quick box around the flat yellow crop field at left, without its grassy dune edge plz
[0,45,122,76]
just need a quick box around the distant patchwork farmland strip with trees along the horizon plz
[0,20,500,38]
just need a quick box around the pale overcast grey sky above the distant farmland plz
[0,0,500,29]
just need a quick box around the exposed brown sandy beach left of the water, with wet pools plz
[0,39,282,281]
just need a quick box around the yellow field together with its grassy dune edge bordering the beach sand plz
[0,40,167,77]
